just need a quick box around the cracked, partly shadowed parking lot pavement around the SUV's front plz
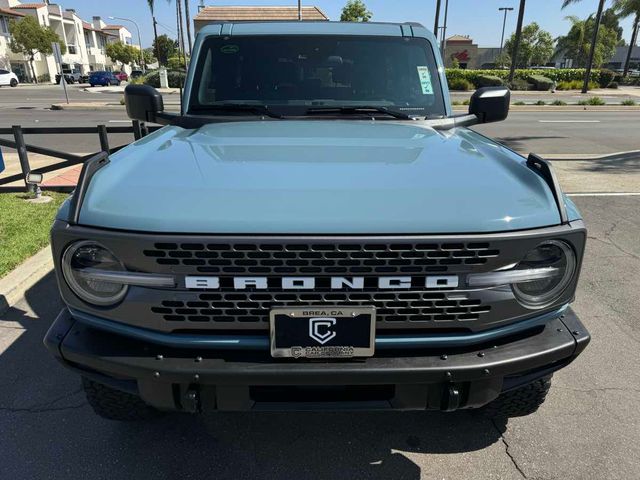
[0,196,640,480]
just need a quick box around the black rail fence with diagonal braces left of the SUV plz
[0,120,160,192]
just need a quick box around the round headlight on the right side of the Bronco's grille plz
[511,240,576,308]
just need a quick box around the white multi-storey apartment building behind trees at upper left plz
[0,0,132,82]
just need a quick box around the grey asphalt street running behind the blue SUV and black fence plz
[0,85,640,155]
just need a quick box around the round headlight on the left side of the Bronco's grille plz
[62,241,127,306]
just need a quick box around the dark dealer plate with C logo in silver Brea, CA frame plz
[270,306,376,358]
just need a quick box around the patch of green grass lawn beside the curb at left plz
[0,192,68,277]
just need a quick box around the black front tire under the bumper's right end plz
[480,376,551,418]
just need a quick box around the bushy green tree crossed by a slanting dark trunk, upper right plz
[556,15,618,68]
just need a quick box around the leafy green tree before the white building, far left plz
[9,16,67,83]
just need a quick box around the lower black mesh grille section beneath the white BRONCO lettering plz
[151,292,491,328]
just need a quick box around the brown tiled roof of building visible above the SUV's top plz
[194,6,329,22]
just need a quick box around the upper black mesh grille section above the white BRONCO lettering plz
[143,242,500,275]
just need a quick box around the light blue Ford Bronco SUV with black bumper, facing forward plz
[45,22,590,420]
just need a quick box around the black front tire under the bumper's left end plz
[82,377,162,422]
